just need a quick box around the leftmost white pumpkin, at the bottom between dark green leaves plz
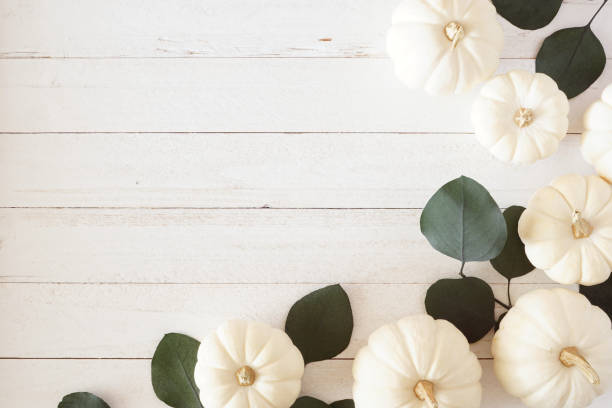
[194,320,304,408]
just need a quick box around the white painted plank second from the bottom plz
[0,282,554,358]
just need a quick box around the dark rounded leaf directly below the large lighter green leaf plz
[425,277,495,343]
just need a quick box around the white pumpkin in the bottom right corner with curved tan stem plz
[492,288,612,408]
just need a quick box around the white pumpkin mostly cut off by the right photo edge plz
[582,84,612,182]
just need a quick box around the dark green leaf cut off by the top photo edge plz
[493,0,563,30]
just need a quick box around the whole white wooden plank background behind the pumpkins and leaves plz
[0,0,612,408]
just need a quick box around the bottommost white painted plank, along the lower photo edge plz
[0,360,612,408]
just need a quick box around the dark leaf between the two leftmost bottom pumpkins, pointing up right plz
[285,285,353,364]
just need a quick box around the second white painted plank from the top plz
[0,58,612,133]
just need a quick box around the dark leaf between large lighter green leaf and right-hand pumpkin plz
[491,206,535,279]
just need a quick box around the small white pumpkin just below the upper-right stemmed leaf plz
[472,71,569,163]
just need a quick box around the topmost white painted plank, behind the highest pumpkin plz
[0,0,612,58]
